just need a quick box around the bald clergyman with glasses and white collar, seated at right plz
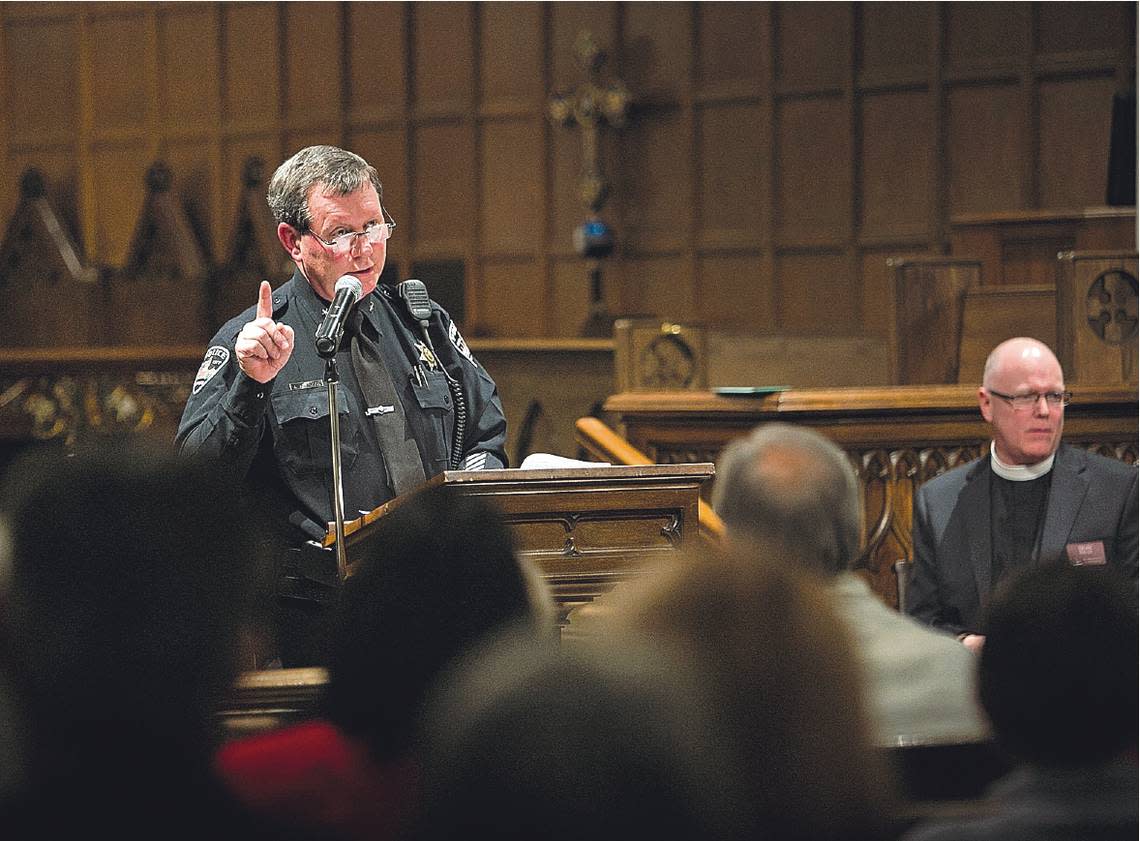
[906,337,1137,651]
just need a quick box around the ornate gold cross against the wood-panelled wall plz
[548,31,632,213]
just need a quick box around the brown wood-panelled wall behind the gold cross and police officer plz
[0,2,1135,337]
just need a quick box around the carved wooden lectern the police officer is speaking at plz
[326,464,714,622]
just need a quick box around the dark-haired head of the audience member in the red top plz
[325,478,544,761]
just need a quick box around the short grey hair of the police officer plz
[266,146,384,230]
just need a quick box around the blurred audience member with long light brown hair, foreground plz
[593,547,894,840]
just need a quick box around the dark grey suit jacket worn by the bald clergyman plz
[906,444,1137,634]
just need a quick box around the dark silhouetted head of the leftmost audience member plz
[3,440,268,779]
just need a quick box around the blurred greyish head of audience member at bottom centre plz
[412,636,742,841]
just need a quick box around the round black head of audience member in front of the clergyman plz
[979,565,1140,766]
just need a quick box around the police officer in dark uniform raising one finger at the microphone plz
[177,146,507,667]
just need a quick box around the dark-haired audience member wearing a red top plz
[218,488,557,839]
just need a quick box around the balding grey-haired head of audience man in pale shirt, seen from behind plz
[713,424,863,574]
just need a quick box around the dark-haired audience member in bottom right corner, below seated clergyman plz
[906,556,1140,841]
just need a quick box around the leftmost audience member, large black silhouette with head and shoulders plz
[0,441,314,839]
